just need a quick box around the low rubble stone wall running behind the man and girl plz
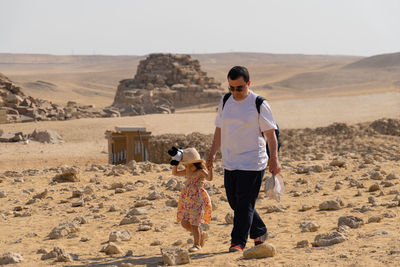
[148,118,400,163]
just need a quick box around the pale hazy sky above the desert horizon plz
[0,0,400,56]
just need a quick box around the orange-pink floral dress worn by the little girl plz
[177,172,212,226]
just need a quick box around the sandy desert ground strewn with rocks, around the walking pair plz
[0,52,400,266]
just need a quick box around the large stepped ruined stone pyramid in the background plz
[109,54,224,116]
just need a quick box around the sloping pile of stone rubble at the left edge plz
[0,73,119,123]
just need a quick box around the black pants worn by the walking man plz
[224,170,267,248]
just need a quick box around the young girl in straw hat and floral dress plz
[172,149,213,252]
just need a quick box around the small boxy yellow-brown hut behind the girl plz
[105,127,151,165]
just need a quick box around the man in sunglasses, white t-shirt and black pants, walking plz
[207,66,281,252]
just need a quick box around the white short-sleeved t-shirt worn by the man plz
[215,90,276,171]
